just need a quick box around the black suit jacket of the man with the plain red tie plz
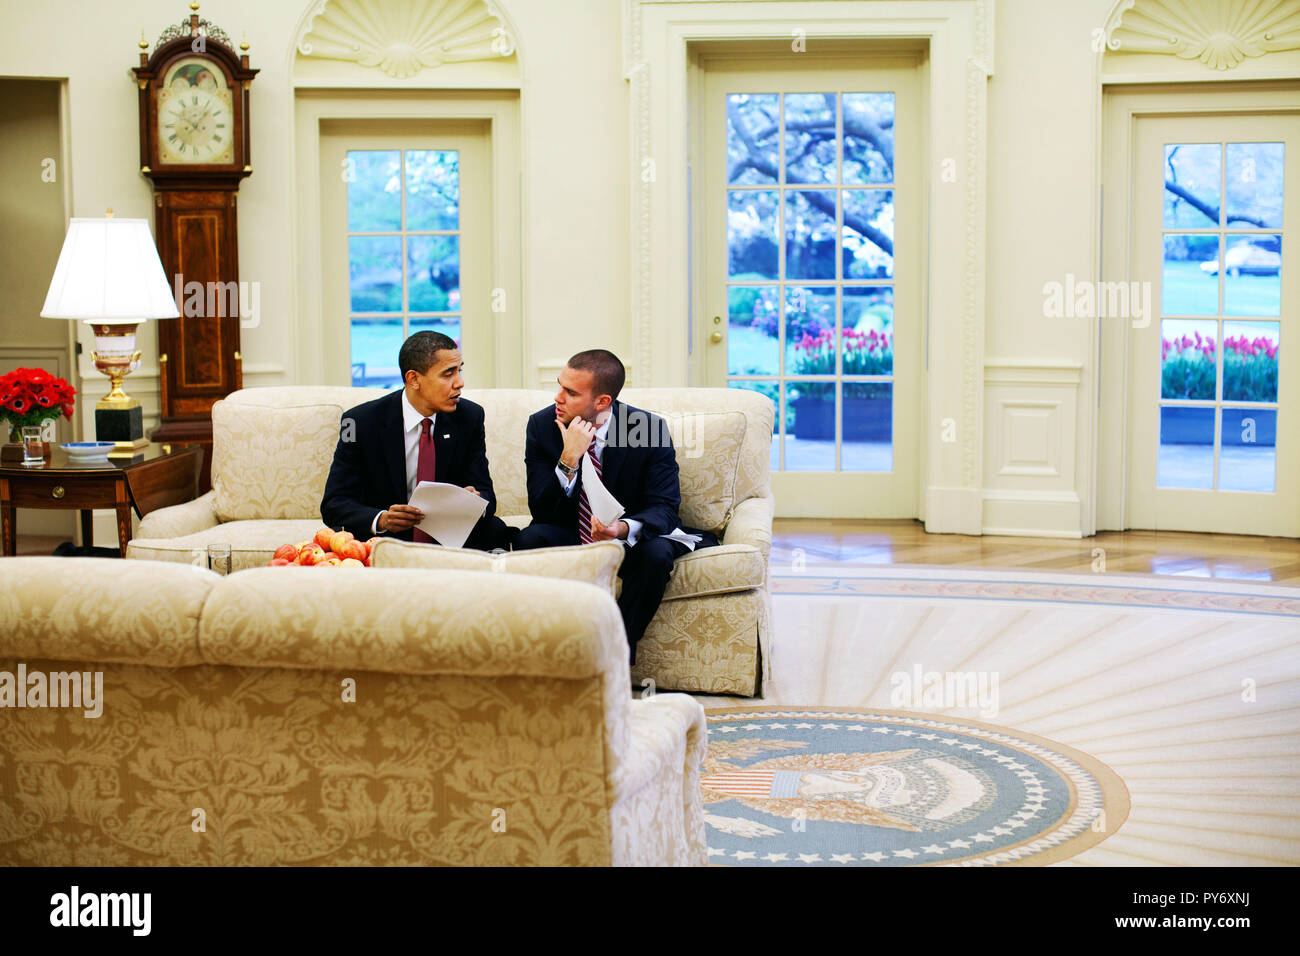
[321,389,497,541]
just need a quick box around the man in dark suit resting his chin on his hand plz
[515,349,718,663]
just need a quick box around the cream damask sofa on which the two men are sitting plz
[127,386,774,696]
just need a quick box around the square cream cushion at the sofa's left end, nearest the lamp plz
[212,402,343,522]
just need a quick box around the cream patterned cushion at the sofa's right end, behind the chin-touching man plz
[666,411,746,535]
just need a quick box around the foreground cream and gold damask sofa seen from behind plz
[0,558,707,866]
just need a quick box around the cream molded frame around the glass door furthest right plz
[1084,81,1300,533]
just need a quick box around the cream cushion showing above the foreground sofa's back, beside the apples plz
[371,538,623,594]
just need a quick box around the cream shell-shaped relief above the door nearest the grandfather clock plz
[298,0,515,79]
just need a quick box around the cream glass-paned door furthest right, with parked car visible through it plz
[1127,113,1300,536]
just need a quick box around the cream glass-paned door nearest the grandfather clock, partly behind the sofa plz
[321,121,495,388]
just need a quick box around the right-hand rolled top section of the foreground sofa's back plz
[199,567,631,681]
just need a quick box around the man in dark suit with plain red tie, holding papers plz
[321,332,511,550]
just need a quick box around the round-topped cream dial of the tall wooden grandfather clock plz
[157,57,235,165]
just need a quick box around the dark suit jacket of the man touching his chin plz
[524,402,681,535]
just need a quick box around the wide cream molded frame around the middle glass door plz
[624,0,993,535]
